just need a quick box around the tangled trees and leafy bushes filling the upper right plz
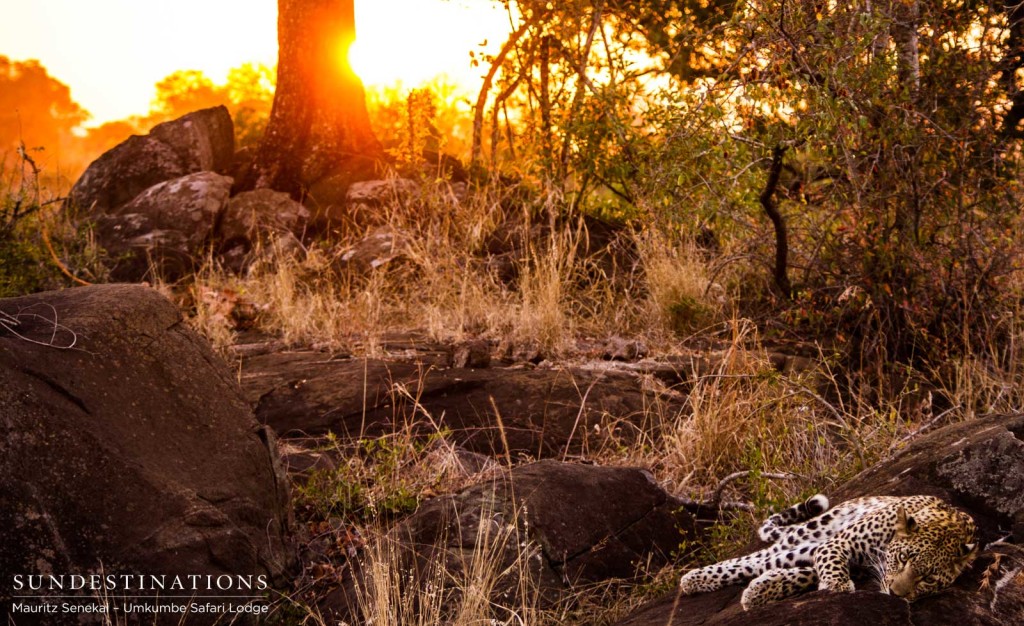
[468,0,1024,376]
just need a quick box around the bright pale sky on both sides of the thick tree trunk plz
[0,0,509,125]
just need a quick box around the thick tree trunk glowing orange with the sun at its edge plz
[243,0,382,198]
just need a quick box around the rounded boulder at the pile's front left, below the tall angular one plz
[95,172,231,282]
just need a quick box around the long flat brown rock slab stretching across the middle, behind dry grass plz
[242,352,680,458]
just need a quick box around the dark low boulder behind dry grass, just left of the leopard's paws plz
[325,461,696,618]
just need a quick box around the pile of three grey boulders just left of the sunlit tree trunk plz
[71,107,309,282]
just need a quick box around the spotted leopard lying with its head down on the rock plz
[679,494,978,610]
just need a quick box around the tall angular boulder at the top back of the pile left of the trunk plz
[69,107,234,216]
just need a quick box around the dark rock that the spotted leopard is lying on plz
[621,415,1024,626]
